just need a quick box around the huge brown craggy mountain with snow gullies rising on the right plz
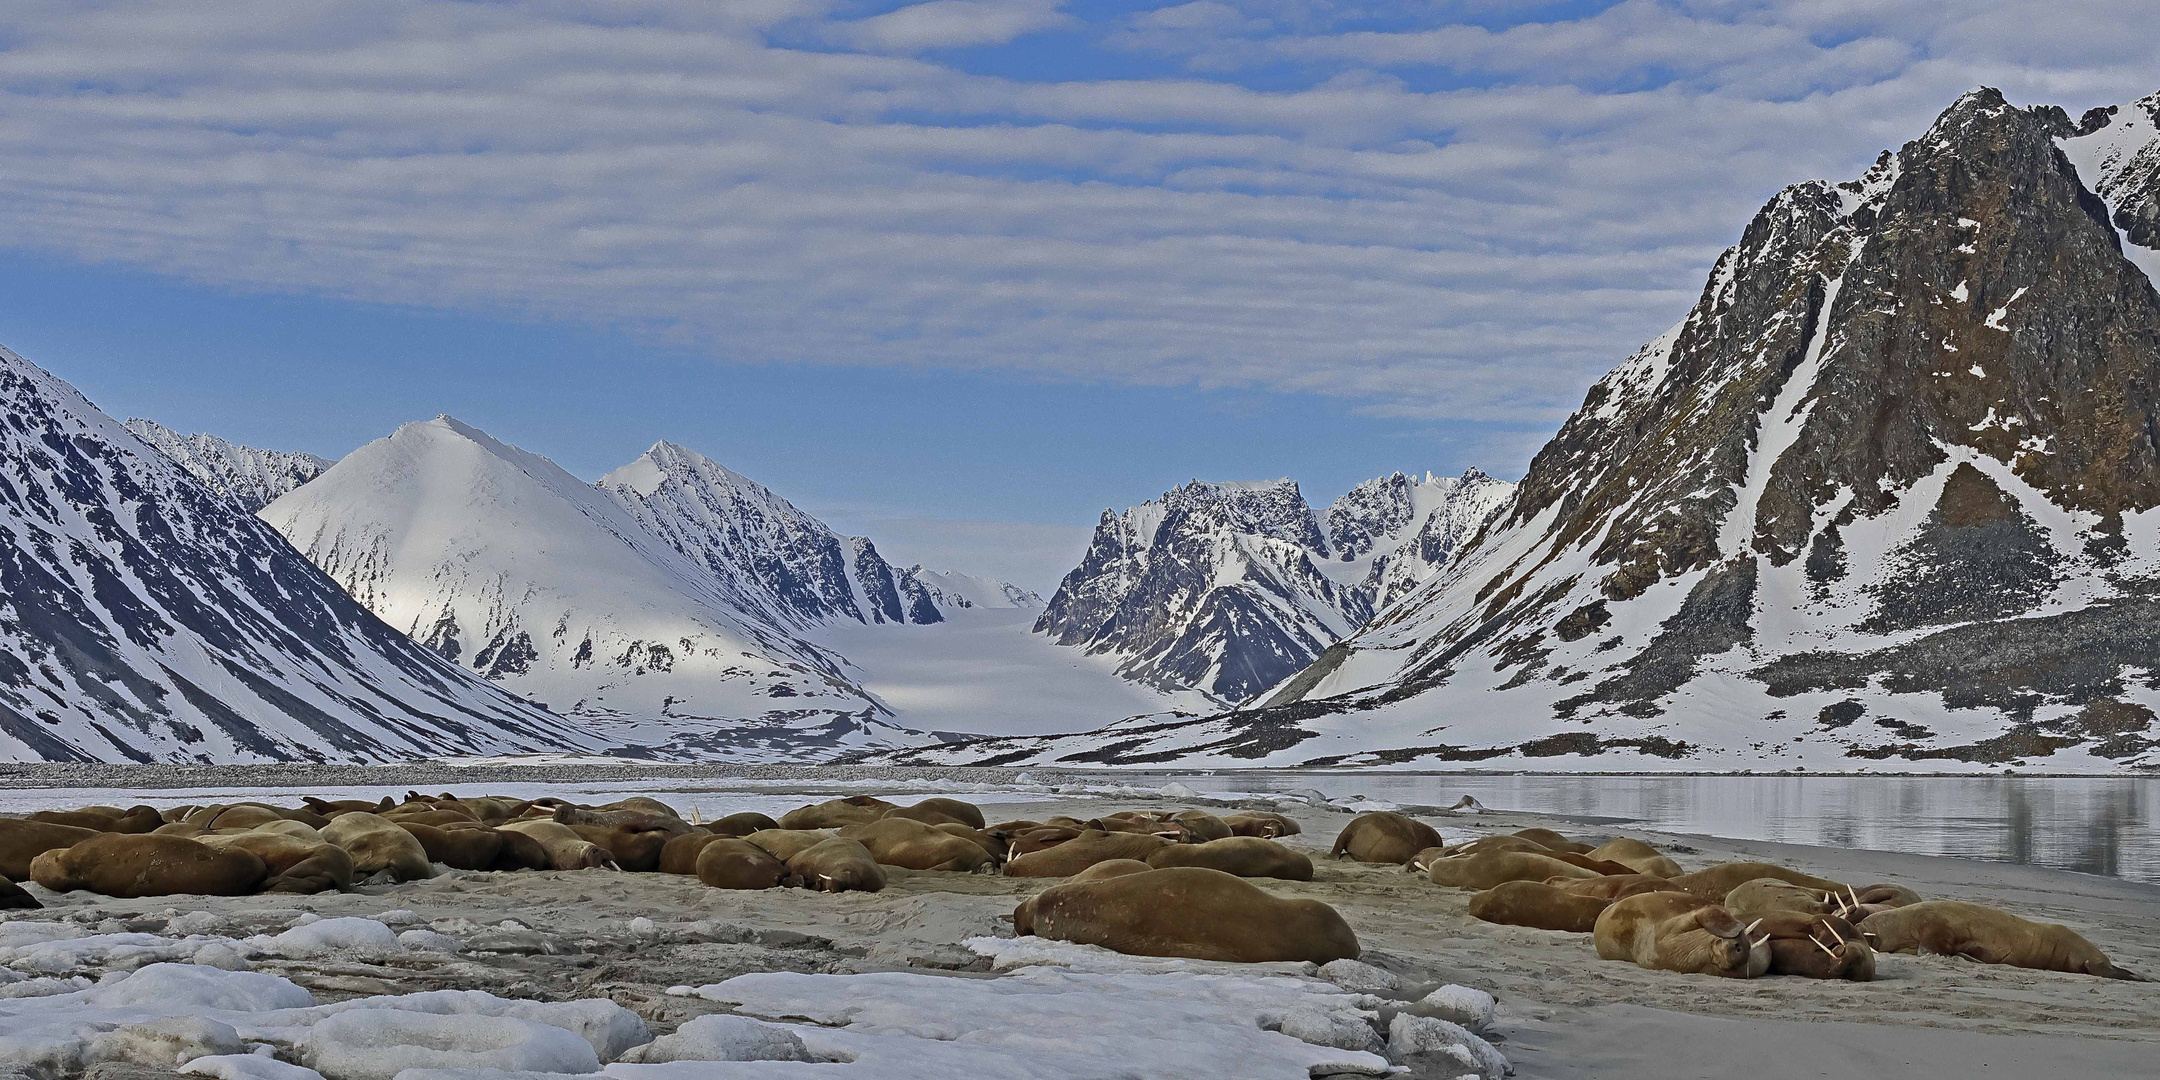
[868,89,2160,771]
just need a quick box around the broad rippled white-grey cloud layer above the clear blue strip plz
[0,0,2160,426]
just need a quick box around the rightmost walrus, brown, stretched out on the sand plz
[1860,901,2149,983]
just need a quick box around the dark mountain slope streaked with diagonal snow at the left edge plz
[0,350,596,762]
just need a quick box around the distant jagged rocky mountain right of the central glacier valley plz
[1035,469,1512,704]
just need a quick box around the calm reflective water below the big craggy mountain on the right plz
[1166,773,2160,881]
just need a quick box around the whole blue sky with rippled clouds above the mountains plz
[0,0,2160,590]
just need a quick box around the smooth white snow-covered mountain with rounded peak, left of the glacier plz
[264,417,922,758]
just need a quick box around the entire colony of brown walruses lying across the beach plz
[0,793,2138,981]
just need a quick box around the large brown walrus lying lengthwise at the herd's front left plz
[30,832,270,899]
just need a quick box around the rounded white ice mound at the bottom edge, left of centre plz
[298,1009,600,1080]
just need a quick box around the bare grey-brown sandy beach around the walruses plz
[11,775,2160,1080]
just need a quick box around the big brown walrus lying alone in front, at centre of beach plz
[1013,866,1359,963]
